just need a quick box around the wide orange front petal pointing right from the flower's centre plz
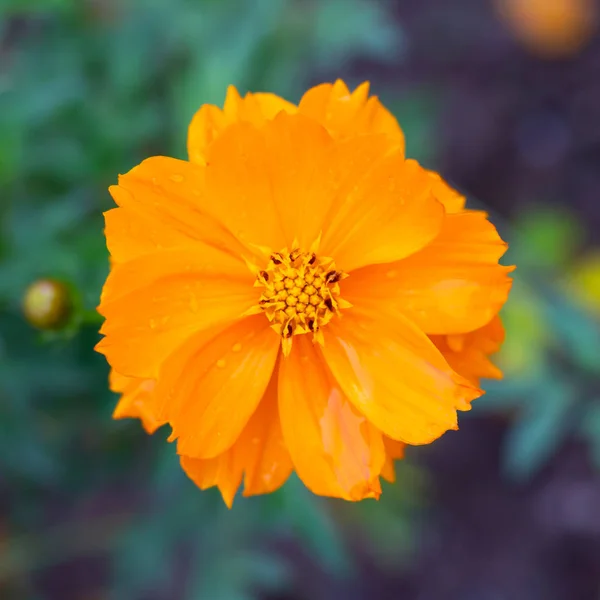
[343,211,512,334]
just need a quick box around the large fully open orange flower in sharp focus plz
[97,81,511,505]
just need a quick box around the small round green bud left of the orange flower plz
[23,279,72,329]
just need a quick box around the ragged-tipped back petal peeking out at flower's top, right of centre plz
[298,79,404,155]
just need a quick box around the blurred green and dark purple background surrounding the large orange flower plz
[0,0,600,600]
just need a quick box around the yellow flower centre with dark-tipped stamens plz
[256,248,350,356]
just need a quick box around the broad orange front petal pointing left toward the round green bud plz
[96,243,257,379]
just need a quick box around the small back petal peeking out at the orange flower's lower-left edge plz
[109,369,164,434]
